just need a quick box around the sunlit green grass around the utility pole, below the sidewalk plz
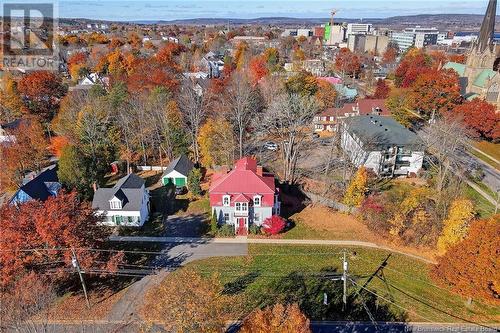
[189,244,500,322]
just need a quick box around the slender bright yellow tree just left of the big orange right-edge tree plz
[437,199,474,254]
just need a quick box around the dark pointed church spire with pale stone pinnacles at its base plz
[467,0,500,71]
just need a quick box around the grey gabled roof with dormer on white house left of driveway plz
[92,174,145,211]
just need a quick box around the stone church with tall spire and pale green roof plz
[443,0,500,109]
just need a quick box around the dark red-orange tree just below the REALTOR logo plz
[18,71,66,123]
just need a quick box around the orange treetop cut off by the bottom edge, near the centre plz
[240,304,311,333]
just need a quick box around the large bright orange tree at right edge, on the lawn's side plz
[431,215,500,306]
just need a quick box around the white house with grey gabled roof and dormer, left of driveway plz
[92,174,150,227]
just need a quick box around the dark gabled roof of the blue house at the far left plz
[9,164,60,203]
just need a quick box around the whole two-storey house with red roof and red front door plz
[209,157,280,235]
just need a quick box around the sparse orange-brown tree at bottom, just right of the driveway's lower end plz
[142,269,231,333]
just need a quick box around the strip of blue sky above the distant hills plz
[2,0,496,21]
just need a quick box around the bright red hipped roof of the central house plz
[209,157,276,194]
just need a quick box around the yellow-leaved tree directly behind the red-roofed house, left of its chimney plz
[198,118,236,167]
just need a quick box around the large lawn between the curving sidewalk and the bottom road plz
[186,244,500,322]
